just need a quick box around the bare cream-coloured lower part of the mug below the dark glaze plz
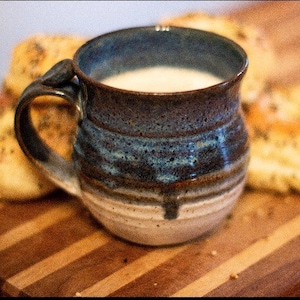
[82,182,244,246]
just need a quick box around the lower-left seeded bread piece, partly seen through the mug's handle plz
[0,99,77,201]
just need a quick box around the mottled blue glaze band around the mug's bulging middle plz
[74,110,247,183]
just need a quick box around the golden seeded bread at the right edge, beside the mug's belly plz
[246,84,300,194]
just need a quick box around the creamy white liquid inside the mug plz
[101,66,223,93]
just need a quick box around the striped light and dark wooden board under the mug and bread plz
[0,1,300,296]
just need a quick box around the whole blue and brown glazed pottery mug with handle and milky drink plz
[15,26,249,246]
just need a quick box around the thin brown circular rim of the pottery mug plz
[72,25,249,96]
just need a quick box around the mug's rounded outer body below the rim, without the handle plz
[73,25,249,245]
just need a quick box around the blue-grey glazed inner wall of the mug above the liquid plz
[74,26,247,88]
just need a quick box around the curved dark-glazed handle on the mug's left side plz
[15,59,81,197]
